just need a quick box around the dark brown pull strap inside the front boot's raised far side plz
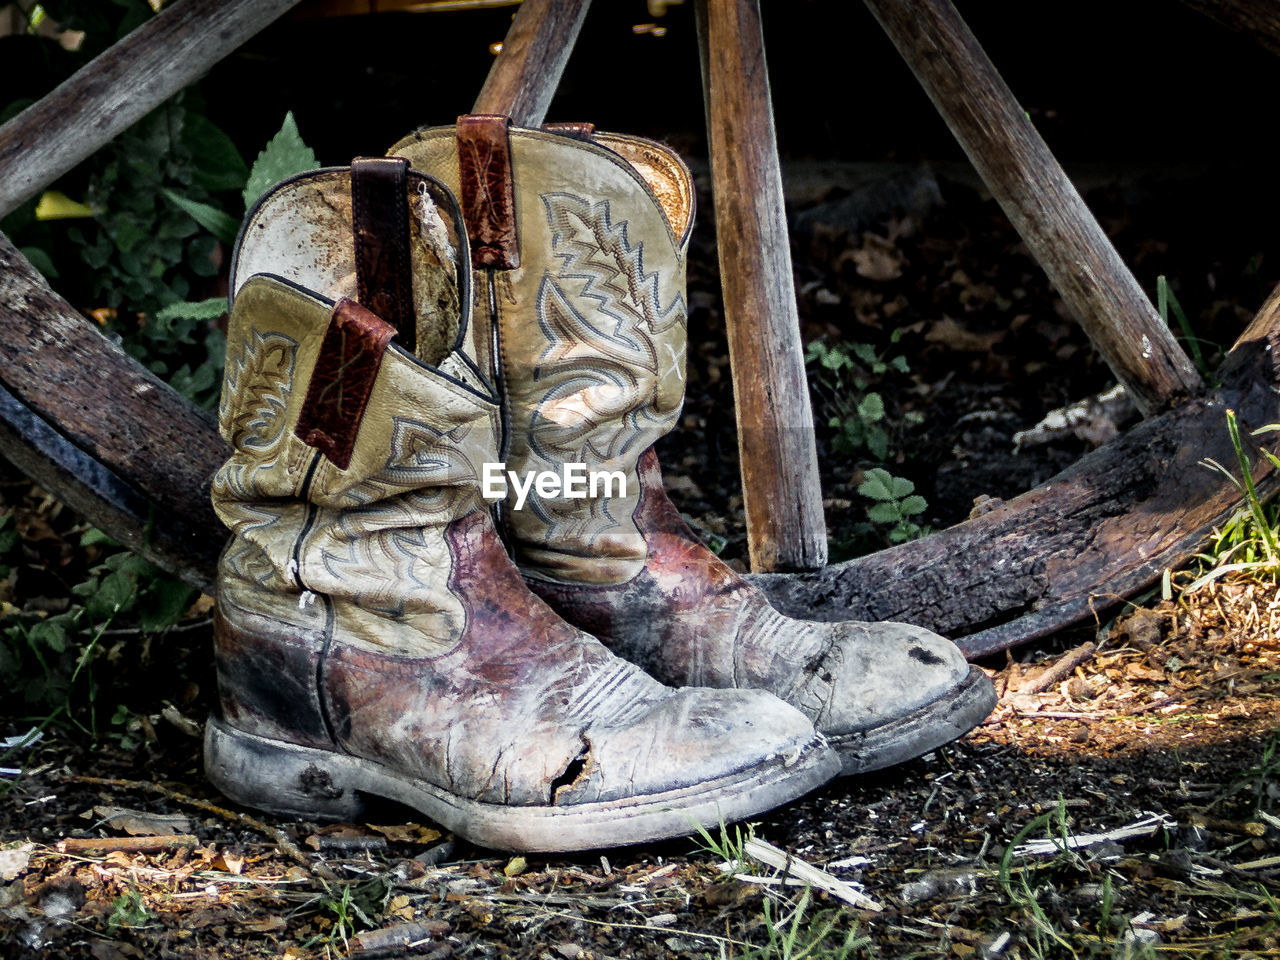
[351,156,417,351]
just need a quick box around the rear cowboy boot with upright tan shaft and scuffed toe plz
[392,116,996,773]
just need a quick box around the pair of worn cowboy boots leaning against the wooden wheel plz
[206,119,993,850]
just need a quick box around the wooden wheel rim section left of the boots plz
[0,234,228,591]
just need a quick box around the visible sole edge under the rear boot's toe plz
[827,667,997,777]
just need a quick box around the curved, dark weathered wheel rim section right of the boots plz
[753,289,1280,657]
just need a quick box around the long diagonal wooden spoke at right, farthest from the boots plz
[865,0,1201,416]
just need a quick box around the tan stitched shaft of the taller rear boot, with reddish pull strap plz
[390,118,694,584]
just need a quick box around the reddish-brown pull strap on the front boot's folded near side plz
[293,297,396,470]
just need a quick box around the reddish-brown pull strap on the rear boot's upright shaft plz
[457,114,520,270]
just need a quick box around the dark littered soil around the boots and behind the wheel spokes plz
[0,169,1280,960]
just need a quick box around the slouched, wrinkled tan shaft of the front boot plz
[214,170,499,653]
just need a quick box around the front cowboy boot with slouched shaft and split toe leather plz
[205,165,838,850]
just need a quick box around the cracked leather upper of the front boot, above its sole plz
[214,168,833,808]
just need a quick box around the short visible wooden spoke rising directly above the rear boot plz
[471,0,591,127]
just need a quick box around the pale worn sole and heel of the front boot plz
[205,717,840,852]
